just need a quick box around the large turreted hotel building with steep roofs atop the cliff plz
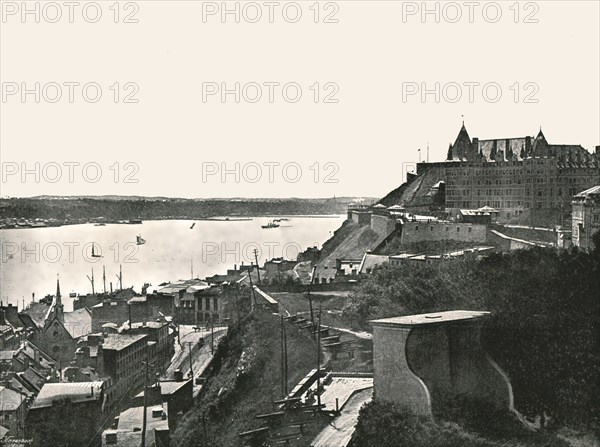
[417,124,600,220]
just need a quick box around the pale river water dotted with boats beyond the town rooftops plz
[0,215,344,310]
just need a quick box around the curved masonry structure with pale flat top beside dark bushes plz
[371,311,513,416]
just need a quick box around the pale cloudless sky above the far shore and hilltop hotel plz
[0,0,600,198]
